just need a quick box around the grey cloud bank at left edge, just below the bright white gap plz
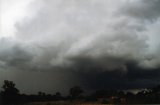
[0,38,32,69]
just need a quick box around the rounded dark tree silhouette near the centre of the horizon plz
[70,86,84,99]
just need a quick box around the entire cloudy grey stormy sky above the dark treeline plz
[0,0,160,93]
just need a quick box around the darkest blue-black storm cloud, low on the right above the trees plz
[74,64,160,90]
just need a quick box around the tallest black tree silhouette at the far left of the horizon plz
[1,80,19,104]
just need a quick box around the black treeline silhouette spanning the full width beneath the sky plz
[0,80,160,105]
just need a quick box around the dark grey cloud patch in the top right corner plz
[122,0,160,21]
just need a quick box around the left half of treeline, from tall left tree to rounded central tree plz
[0,80,83,105]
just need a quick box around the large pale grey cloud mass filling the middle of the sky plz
[16,0,158,70]
